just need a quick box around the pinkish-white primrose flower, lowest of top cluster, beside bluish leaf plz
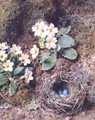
[45,36,57,49]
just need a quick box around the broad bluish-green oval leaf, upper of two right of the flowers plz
[58,35,75,48]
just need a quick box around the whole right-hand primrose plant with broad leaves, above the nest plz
[30,21,77,70]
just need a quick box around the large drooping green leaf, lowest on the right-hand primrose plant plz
[42,54,56,70]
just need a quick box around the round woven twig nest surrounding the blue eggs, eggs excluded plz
[43,68,92,115]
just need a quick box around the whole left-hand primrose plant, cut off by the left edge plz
[0,42,33,96]
